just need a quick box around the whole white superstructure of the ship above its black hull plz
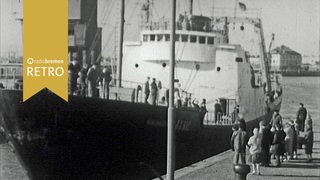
[122,0,271,124]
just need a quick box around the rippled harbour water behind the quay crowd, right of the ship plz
[280,77,320,123]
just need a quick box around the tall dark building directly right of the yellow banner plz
[68,0,101,65]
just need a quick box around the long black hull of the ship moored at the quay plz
[0,90,271,179]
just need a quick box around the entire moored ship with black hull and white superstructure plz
[0,1,282,180]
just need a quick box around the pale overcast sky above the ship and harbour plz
[0,0,320,59]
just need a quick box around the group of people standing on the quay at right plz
[231,103,313,175]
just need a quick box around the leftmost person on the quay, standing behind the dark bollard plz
[231,121,248,164]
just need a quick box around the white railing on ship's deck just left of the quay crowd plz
[203,111,236,126]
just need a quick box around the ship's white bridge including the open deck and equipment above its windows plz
[134,5,228,64]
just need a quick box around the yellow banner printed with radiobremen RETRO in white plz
[23,0,68,101]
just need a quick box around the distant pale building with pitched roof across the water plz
[271,45,302,71]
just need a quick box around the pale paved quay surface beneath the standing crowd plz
[163,119,320,180]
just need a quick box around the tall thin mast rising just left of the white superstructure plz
[116,0,125,87]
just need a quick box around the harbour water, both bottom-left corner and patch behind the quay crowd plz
[0,77,320,180]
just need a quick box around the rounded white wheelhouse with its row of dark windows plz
[140,30,224,63]
